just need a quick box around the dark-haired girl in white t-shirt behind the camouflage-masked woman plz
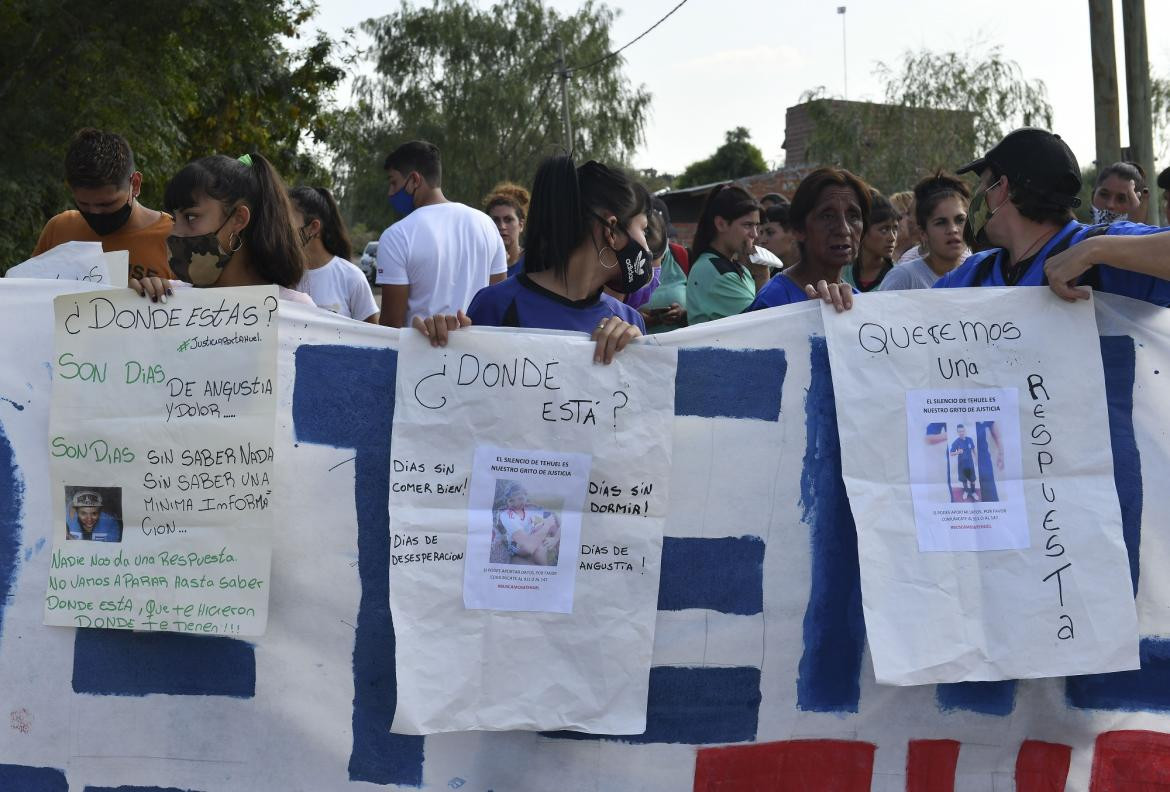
[289,187,378,324]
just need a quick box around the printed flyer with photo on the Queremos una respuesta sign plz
[906,387,1031,551]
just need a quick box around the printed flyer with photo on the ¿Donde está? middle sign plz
[463,446,592,613]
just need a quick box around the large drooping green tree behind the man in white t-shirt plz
[332,0,651,227]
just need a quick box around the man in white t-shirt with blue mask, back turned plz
[377,140,508,328]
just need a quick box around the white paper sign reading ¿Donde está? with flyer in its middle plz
[390,330,677,734]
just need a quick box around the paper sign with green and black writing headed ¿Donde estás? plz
[44,287,277,635]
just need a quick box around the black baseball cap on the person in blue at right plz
[956,126,1081,208]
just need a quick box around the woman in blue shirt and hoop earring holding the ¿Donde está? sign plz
[414,157,654,363]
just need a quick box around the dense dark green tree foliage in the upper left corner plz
[0,0,344,270]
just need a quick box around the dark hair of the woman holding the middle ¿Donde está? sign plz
[524,156,651,278]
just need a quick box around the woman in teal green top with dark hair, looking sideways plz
[687,185,761,324]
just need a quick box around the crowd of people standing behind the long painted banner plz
[20,128,1170,363]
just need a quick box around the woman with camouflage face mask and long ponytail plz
[130,154,312,305]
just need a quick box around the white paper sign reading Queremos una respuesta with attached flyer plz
[824,289,1138,684]
